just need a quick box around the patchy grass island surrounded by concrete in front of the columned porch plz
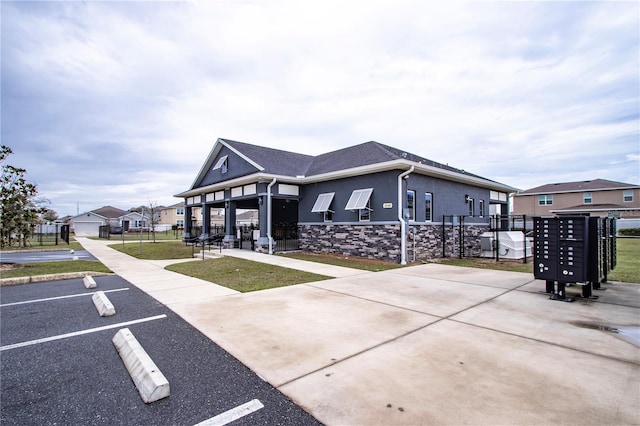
[166,257,332,293]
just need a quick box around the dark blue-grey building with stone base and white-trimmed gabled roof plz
[176,139,516,263]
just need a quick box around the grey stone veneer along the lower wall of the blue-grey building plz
[298,223,488,262]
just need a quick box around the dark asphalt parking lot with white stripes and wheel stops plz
[0,276,319,425]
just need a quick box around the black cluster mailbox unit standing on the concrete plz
[533,216,616,302]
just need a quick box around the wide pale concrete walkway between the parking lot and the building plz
[81,239,640,425]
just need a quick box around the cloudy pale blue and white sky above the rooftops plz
[0,0,640,216]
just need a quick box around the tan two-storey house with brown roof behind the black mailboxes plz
[513,179,640,219]
